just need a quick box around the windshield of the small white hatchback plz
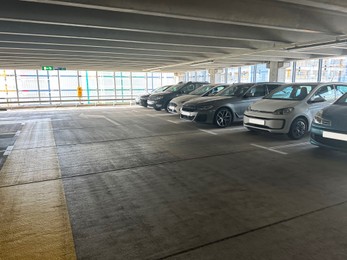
[265,84,317,100]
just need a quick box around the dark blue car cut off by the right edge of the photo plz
[311,93,347,150]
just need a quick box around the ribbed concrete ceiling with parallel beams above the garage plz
[0,0,347,72]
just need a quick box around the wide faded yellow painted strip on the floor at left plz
[0,120,76,259]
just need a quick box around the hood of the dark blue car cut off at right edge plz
[323,105,347,132]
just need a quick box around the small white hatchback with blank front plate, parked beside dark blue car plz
[243,83,347,139]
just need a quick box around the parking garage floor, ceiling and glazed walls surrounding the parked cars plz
[0,0,347,260]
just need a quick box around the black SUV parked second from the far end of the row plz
[147,81,209,111]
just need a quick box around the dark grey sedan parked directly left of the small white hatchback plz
[180,82,282,127]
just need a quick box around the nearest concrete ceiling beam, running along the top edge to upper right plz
[21,0,347,34]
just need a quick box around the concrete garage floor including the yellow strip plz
[0,106,347,260]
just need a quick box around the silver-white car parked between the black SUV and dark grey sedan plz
[168,84,231,114]
